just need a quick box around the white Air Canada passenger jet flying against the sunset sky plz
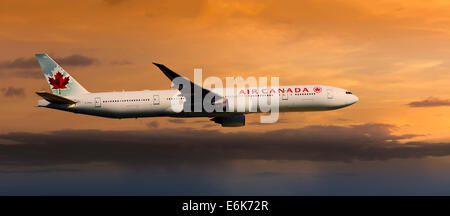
[35,54,358,127]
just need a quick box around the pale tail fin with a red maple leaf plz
[36,54,89,96]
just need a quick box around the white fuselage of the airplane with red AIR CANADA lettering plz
[38,85,358,118]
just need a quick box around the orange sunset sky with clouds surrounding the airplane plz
[0,0,450,194]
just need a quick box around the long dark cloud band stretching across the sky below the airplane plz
[0,124,450,166]
